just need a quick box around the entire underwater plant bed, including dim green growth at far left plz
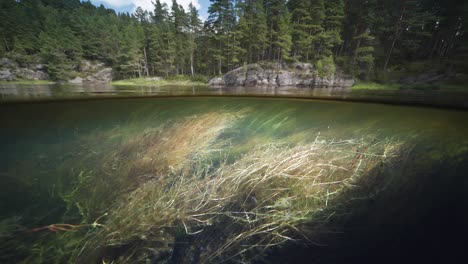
[0,98,468,263]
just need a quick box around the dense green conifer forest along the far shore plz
[0,0,468,79]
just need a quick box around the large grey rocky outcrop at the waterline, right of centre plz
[209,63,354,88]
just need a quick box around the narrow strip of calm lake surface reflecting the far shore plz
[0,84,468,108]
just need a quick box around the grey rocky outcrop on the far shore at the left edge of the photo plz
[0,58,49,81]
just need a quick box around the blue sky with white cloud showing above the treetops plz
[90,0,210,19]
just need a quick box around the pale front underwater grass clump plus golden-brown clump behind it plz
[66,113,406,262]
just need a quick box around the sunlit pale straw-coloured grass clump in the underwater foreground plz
[76,134,400,262]
